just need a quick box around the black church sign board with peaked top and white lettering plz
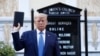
[38,3,81,56]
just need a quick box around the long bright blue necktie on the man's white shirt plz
[38,32,44,56]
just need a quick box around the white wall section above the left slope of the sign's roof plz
[30,0,66,10]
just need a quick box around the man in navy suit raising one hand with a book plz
[12,13,60,56]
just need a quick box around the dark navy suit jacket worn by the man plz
[12,30,60,56]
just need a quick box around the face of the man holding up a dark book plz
[34,16,47,31]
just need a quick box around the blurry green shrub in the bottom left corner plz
[0,42,15,56]
